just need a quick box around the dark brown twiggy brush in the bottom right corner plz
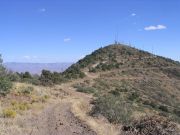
[122,116,179,135]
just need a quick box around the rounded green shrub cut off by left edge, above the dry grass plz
[0,76,12,96]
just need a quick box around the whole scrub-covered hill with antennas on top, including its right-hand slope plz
[63,45,180,132]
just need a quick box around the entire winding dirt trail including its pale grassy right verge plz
[26,72,118,135]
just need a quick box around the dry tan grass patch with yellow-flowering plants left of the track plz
[0,83,51,135]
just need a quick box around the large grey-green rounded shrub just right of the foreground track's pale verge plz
[91,95,133,123]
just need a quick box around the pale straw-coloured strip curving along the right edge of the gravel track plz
[56,78,120,135]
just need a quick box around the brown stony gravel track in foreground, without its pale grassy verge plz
[31,102,96,135]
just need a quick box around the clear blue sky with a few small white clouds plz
[0,0,180,63]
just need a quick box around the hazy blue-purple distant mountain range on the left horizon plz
[4,62,73,74]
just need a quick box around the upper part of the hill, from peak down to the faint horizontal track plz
[64,44,180,77]
